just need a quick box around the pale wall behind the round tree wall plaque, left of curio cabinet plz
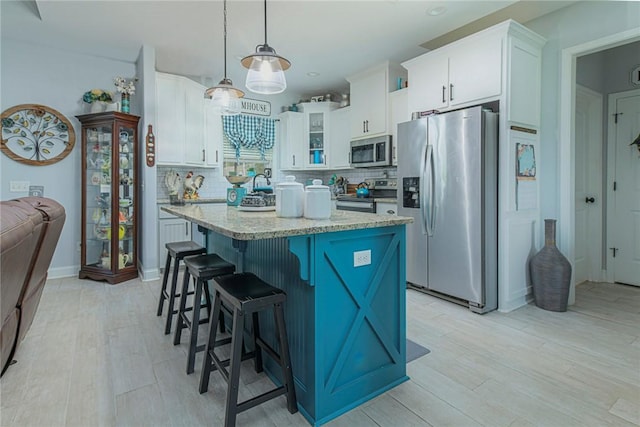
[0,38,138,277]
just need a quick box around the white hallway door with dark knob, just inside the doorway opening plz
[574,86,603,284]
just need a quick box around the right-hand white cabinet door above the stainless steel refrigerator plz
[448,34,502,106]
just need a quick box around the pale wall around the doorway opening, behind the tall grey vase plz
[526,1,640,253]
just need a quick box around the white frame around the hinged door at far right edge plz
[605,89,640,283]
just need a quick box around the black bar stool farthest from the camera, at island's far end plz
[158,240,207,335]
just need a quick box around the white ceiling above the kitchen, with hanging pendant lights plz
[0,0,573,96]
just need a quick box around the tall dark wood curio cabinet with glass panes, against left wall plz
[77,112,140,284]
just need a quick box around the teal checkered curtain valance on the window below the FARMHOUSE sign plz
[222,114,276,160]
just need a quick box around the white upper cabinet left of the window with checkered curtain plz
[155,73,220,167]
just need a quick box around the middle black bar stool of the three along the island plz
[173,254,236,374]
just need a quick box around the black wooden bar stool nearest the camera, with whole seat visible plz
[200,273,298,427]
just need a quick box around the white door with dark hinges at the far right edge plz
[608,91,640,286]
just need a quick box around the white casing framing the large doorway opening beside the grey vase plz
[558,29,640,304]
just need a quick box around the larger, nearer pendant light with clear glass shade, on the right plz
[241,0,291,95]
